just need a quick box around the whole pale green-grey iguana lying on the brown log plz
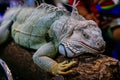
[0,3,105,75]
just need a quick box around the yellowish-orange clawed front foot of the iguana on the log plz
[51,61,77,75]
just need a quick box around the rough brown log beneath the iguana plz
[0,41,120,80]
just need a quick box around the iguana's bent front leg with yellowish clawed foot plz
[33,42,76,75]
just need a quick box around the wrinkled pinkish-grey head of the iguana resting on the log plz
[59,16,105,57]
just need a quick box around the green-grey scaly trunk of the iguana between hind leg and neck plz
[12,4,63,49]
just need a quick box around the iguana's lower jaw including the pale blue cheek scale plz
[59,41,104,57]
